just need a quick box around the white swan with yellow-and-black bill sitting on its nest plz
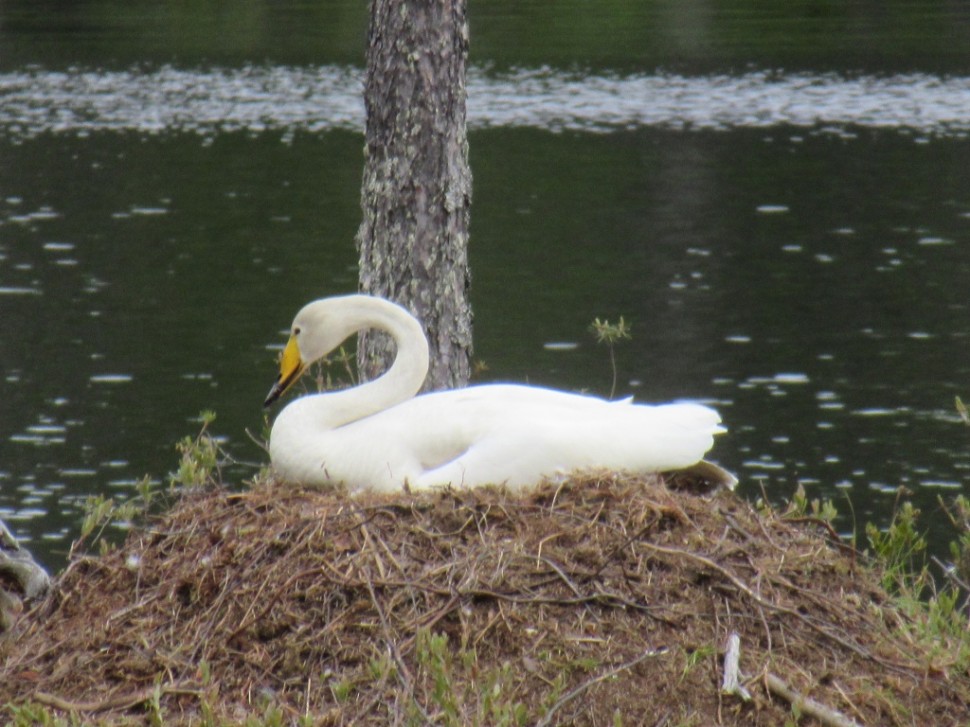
[264,295,736,492]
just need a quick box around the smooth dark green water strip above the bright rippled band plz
[0,0,970,73]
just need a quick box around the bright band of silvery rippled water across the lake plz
[0,66,970,139]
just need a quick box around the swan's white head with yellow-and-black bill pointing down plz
[263,298,355,406]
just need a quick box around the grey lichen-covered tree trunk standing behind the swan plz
[357,0,472,389]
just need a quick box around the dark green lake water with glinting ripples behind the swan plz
[0,2,970,564]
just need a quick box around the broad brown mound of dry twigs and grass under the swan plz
[0,476,970,725]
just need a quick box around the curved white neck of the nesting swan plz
[312,295,428,427]
